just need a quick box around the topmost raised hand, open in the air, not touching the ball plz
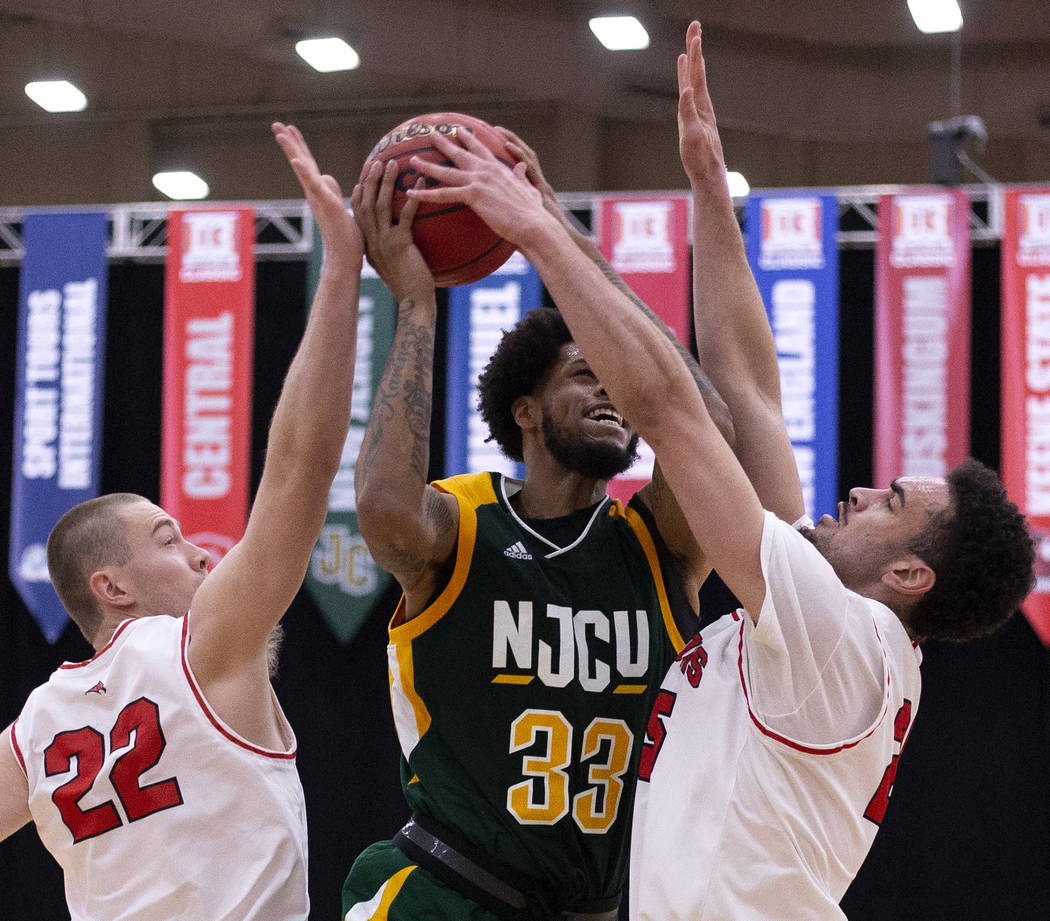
[678,20,726,185]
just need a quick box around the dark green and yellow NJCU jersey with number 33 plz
[387,474,696,903]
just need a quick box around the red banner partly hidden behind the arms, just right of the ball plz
[599,195,692,502]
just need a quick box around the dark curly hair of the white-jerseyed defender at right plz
[908,458,1035,643]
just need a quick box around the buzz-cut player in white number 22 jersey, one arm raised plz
[0,124,363,921]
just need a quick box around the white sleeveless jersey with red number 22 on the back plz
[12,615,309,921]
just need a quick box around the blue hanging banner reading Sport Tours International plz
[7,212,106,643]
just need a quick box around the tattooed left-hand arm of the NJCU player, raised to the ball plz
[351,162,459,618]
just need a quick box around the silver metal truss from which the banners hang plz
[0,185,1004,266]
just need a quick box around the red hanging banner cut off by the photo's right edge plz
[1000,187,1050,646]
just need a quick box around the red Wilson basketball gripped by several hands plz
[361,112,515,288]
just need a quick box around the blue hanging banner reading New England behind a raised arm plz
[746,192,839,521]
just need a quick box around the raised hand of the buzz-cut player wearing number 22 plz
[271,122,364,272]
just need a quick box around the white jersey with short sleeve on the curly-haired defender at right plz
[630,514,921,921]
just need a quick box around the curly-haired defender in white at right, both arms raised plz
[375,23,1032,921]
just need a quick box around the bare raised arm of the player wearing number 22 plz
[189,123,364,729]
